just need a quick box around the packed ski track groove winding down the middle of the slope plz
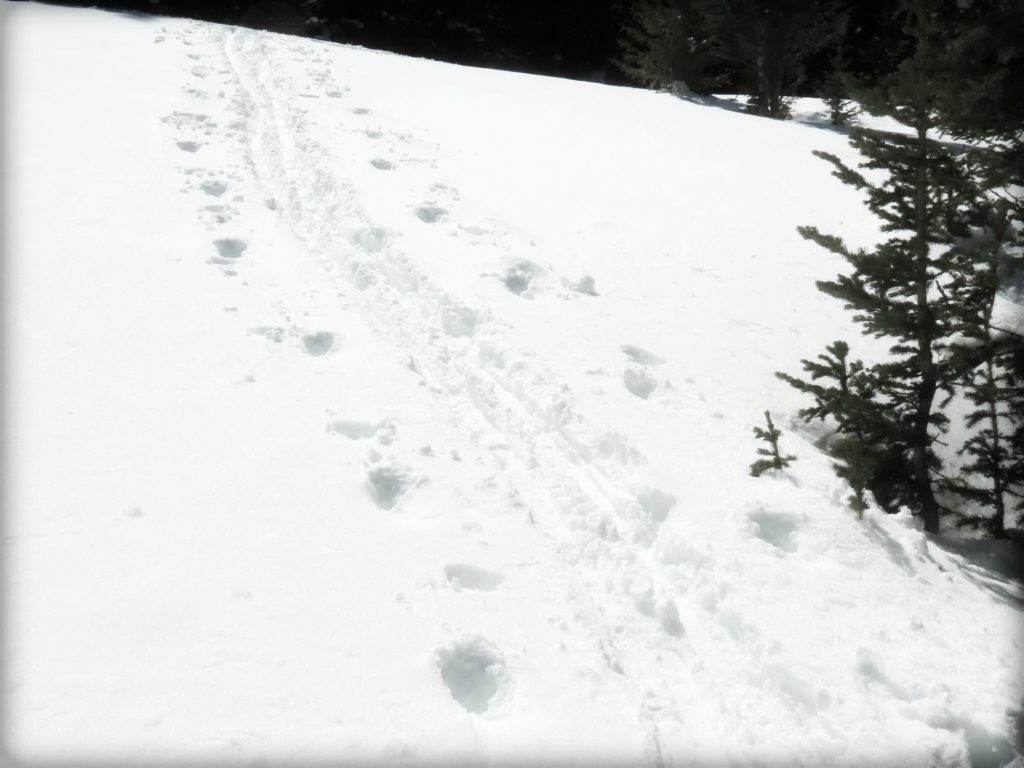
[216,30,839,766]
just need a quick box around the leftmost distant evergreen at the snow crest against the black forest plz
[616,0,709,93]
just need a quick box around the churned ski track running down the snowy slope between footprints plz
[172,26,901,766]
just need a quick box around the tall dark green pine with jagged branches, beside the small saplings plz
[786,0,978,532]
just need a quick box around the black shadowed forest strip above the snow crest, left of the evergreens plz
[34,0,631,84]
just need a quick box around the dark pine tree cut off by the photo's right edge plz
[936,0,1024,538]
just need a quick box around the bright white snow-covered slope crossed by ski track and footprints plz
[3,4,1024,766]
